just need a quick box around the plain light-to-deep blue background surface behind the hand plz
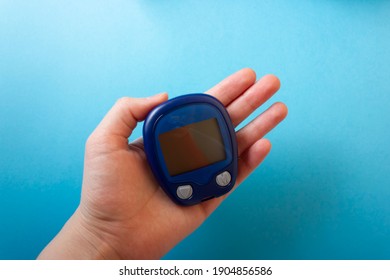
[0,0,390,259]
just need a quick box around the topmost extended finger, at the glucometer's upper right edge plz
[206,68,256,107]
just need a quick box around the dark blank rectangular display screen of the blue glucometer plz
[158,118,226,176]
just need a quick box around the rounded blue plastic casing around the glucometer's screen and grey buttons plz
[143,93,238,205]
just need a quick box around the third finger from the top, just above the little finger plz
[236,102,288,155]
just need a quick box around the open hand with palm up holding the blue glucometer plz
[39,69,287,259]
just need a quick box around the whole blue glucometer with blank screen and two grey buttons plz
[143,94,238,205]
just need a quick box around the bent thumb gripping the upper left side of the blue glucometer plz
[93,93,168,145]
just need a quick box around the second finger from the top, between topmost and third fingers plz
[227,75,280,126]
